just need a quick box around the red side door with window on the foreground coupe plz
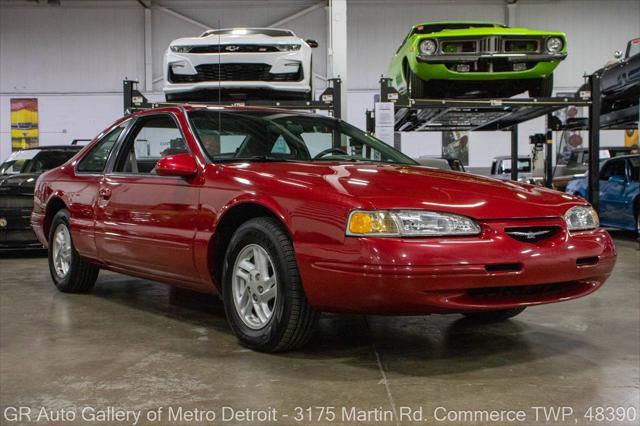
[96,113,200,287]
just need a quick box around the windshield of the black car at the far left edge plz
[0,149,77,175]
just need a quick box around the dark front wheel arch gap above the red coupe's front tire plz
[207,200,293,291]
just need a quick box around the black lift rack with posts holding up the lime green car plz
[366,74,638,209]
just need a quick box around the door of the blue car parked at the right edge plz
[598,158,628,226]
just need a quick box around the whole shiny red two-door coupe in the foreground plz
[31,106,616,352]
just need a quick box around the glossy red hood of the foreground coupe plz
[231,162,585,219]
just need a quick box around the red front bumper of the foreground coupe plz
[296,219,616,315]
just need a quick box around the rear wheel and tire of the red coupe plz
[49,209,100,293]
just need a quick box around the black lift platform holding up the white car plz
[122,78,342,118]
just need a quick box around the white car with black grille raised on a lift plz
[164,28,318,101]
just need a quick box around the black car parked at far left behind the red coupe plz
[0,145,82,250]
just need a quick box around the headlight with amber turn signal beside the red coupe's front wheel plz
[347,210,480,237]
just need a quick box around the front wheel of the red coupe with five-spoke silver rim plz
[222,217,318,352]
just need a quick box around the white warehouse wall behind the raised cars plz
[0,0,640,166]
